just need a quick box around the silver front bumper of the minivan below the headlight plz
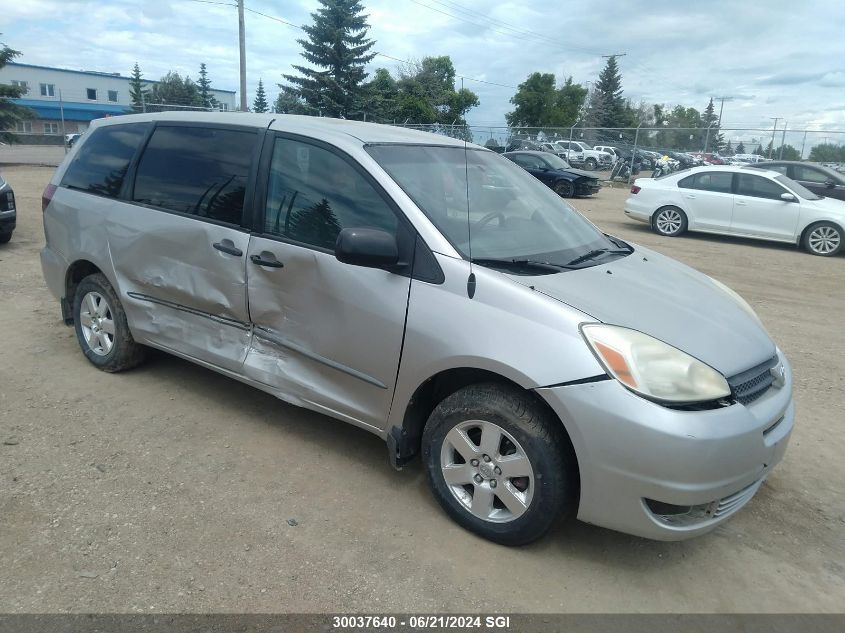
[537,352,795,541]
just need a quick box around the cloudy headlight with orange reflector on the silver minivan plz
[581,323,731,404]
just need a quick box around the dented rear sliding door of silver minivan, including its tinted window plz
[109,123,258,371]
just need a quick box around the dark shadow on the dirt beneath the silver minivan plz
[131,351,708,569]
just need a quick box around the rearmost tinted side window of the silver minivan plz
[62,123,150,198]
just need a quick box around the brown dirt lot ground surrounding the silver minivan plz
[0,167,845,612]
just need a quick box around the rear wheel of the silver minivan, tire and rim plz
[73,273,146,373]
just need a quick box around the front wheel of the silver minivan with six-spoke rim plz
[422,383,578,545]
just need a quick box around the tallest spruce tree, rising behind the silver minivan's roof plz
[284,0,375,118]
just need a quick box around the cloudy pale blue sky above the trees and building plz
[0,0,845,147]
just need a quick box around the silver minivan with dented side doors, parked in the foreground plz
[41,113,794,544]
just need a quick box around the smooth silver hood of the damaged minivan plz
[511,245,775,377]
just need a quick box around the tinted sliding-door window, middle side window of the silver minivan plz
[132,125,258,224]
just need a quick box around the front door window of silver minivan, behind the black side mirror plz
[264,138,398,249]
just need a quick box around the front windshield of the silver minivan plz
[367,145,630,274]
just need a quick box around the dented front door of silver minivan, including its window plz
[243,137,412,428]
